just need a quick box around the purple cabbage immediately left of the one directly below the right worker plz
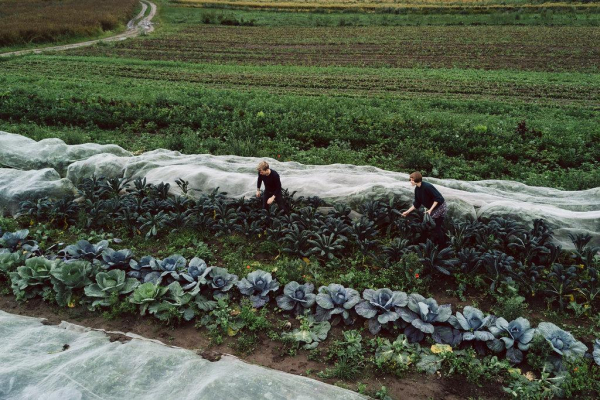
[355,288,408,335]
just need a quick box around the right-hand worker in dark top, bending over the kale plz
[402,171,448,247]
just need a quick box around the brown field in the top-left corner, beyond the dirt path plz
[0,0,139,46]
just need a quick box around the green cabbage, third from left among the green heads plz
[84,269,140,309]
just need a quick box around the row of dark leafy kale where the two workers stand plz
[20,177,600,311]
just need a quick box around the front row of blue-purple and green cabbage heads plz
[0,230,600,371]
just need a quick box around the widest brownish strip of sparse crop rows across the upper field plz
[72,25,600,72]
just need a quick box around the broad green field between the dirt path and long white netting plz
[0,2,600,190]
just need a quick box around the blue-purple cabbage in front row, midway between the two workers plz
[315,283,360,325]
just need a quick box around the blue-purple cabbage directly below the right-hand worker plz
[398,293,452,343]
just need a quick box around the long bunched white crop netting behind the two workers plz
[0,132,600,248]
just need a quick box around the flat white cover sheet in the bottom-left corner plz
[0,311,364,400]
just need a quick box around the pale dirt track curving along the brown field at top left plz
[0,0,156,57]
